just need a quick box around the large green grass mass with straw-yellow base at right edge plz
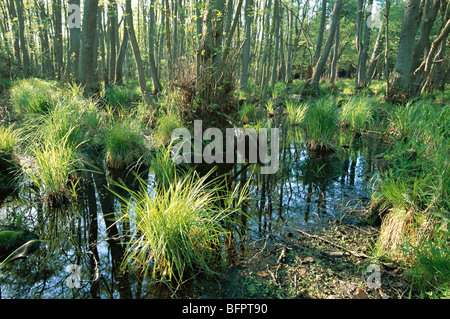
[370,101,450,268]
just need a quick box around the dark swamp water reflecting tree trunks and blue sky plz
[0,130,383,299]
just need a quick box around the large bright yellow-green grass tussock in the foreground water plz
[115,173,247,285]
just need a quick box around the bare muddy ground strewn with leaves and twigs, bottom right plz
[192,208,414,299]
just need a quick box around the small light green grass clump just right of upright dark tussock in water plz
[340,97,374,134]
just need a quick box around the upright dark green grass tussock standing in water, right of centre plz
[305,97,338,153]
